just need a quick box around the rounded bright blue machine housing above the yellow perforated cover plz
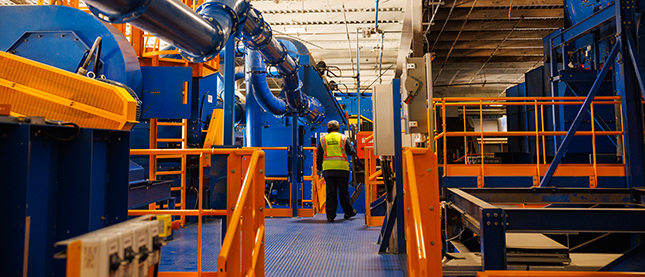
[0,6,142,94]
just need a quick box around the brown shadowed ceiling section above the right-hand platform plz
[423,0,564,97]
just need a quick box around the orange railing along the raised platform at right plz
[428,96,624,188]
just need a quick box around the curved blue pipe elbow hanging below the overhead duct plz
[244,49,287,116]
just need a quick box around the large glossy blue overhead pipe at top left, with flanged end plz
[85,0,249,62]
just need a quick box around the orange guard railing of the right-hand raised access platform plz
[428,96,624,188]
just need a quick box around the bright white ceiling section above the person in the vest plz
[251,0,405,92]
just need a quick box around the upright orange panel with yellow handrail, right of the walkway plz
[403,148,443,276]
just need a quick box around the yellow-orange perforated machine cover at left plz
[0,51,137,130]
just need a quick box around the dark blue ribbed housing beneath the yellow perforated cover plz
[0,123,130,276]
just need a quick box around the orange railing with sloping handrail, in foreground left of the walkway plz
[128,148,265,277]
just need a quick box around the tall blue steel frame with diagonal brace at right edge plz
[539,1,645,188]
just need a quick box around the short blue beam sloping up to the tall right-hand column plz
[552,4,616,48]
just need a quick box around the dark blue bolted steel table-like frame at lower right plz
[444,188,645,270]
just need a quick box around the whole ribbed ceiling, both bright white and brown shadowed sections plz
[0,0,564,97]
